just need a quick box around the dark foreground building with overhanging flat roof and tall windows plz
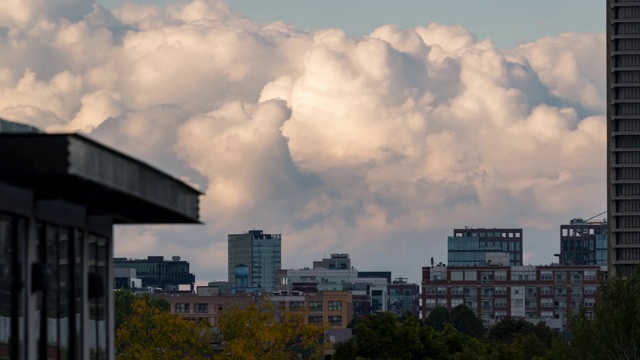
[0,121,200,359]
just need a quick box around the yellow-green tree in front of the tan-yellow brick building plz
[216,301,324,360]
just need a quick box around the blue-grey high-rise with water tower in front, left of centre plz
[228,230,282,291]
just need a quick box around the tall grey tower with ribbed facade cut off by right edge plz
[607,0,640,276]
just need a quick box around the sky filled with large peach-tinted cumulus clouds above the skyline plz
[0,0,606,284]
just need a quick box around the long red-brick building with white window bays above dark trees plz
[422,265,604,329]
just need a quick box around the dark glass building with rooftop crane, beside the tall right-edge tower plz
[560,218,608,265]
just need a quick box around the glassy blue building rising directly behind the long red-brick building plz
[447,228,522,266]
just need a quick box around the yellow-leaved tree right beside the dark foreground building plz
[115,295,212,360]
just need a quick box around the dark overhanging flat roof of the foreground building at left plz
[0,133,202,224]
